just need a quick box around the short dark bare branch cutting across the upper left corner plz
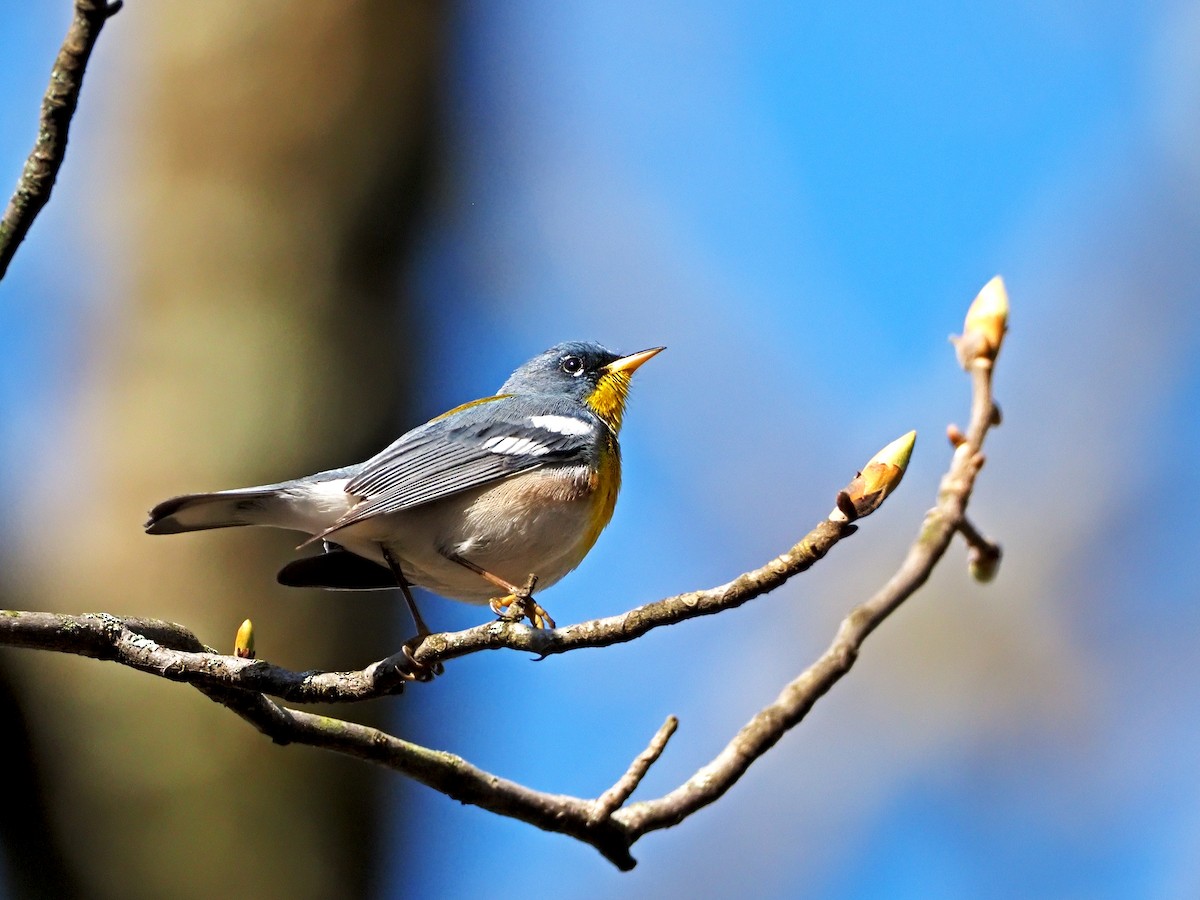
[0,0,122,278]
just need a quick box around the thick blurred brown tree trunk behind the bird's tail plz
[7,0,444,898]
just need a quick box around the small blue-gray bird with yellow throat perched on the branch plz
[145,342,664,634]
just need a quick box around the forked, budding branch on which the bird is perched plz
[0,278,1008,870]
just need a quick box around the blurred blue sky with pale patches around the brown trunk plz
[0,0,1200,899]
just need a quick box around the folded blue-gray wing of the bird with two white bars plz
[325,396,604,534]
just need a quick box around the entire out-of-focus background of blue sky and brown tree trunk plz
[0,0,1200,898]
